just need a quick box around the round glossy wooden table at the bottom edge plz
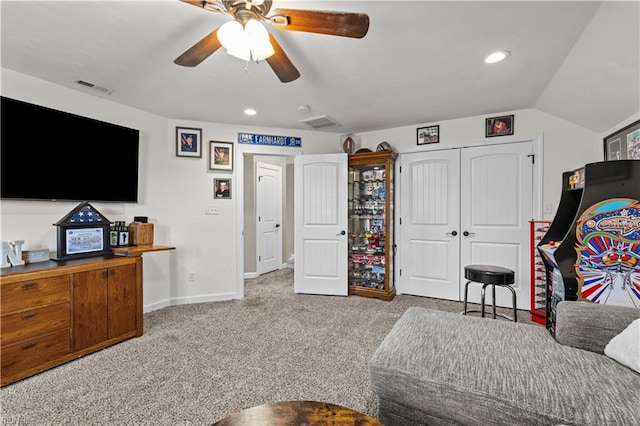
[214,401,382,426]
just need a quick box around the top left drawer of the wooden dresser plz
[0,275,69,314]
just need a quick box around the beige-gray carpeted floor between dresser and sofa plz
[0,269,537,426]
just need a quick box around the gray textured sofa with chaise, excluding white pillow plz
[369,302,640,426]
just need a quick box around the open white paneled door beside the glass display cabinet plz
[294,154,349,296]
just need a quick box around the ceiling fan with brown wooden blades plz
[173,0,369,83]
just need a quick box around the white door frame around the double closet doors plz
[393,132,544,294]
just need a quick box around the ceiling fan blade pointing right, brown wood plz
[269,9,369,38]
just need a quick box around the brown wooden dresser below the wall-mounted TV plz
[0,255,143,386]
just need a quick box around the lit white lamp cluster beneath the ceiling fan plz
[218,19,275,61]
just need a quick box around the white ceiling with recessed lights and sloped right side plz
[0,0,640,133]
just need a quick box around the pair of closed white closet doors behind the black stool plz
[397,142,533,309]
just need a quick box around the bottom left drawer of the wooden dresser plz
[0,330,71,377]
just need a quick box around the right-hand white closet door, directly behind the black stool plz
[460,143,534,309]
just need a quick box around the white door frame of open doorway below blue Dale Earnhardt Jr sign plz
[234,142,302,299]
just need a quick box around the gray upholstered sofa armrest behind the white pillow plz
[556,300,640,354]
